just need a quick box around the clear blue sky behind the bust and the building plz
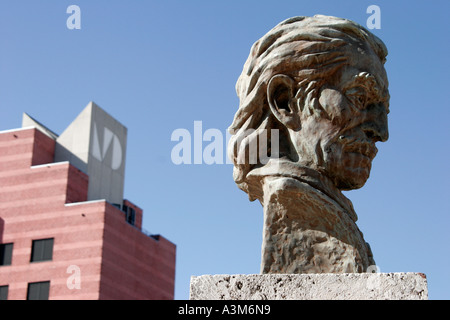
[0,0,450,299]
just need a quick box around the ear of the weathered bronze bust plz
[267,74,301,131]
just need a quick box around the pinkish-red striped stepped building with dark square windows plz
[0,104,176,300]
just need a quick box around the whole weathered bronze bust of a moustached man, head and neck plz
[228,15,389,273]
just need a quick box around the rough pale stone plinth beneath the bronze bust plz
[190,273,428,300]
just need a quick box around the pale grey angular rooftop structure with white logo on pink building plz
[22,102,127,206]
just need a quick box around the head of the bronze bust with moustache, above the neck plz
[229,16,389,199]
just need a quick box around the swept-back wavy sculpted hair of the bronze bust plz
[228,15,387,192]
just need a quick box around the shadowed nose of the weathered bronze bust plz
[362,103,389,142]
